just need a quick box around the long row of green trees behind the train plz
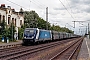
[24,11,73,33]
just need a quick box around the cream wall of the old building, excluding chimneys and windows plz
[0,8,24,39]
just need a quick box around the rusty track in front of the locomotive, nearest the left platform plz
[0,39,71,55]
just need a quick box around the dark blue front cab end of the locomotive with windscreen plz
[23,28,38,43]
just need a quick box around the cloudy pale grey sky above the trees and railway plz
[0,0,90,34]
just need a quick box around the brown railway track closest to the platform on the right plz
[50,38,83,60]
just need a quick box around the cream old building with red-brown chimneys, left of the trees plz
[0,4,24,38]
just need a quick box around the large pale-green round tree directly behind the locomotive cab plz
[24,11,39,28]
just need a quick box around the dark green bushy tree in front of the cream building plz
[0,20,16,40]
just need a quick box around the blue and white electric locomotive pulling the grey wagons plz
[23,28,52,44]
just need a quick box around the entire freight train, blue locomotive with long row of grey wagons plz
[23,28,78,44]
